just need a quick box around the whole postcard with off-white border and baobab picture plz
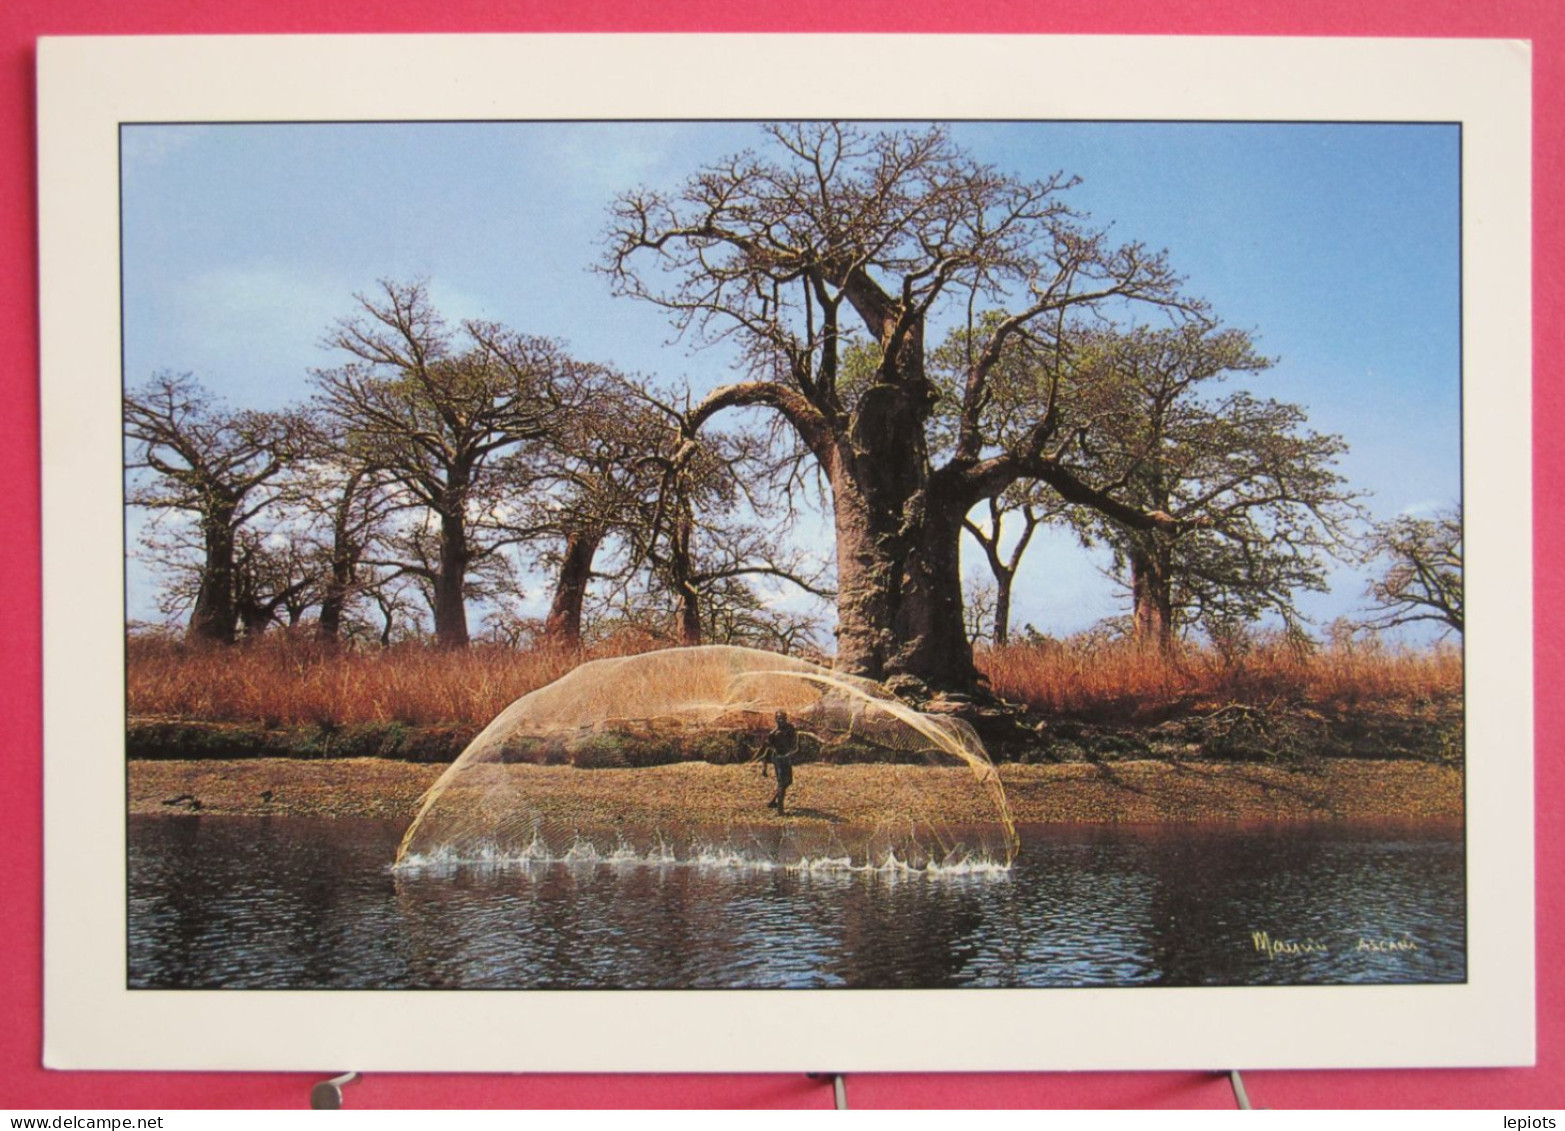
[39,36,1534,1072]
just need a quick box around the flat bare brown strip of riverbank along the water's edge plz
[130,759,1462,824]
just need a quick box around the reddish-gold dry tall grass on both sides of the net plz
[127,635,1462,727]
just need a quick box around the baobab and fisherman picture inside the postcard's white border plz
[119,119,1468,990]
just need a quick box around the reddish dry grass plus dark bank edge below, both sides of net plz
[127,637,1462,765]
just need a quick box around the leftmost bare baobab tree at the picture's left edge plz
[124,372,305,644]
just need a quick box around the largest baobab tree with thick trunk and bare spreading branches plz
[603,124,1197,688]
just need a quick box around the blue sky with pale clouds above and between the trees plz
[122,122,1460,634]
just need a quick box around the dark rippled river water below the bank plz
[127,817,1466,989]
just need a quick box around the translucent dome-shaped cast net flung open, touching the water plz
[398,646,1017,873]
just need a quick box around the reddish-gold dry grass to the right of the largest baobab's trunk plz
[978,631,1462,723]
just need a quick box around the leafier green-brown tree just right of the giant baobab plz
[1070,325,1360,652]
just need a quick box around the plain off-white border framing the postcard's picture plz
[39,36,1534,1072]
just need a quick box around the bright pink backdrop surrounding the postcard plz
[0,0,1565,1112]
